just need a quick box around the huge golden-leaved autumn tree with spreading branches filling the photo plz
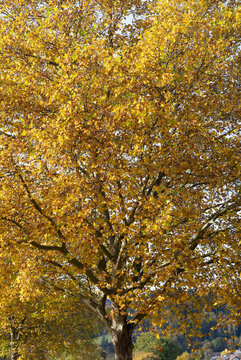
[0,0,241,360]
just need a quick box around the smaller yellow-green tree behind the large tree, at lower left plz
[0,249,97,360]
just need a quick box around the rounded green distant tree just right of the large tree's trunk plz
[135,333,182,360]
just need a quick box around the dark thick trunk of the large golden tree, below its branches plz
[111,316,134,360]
